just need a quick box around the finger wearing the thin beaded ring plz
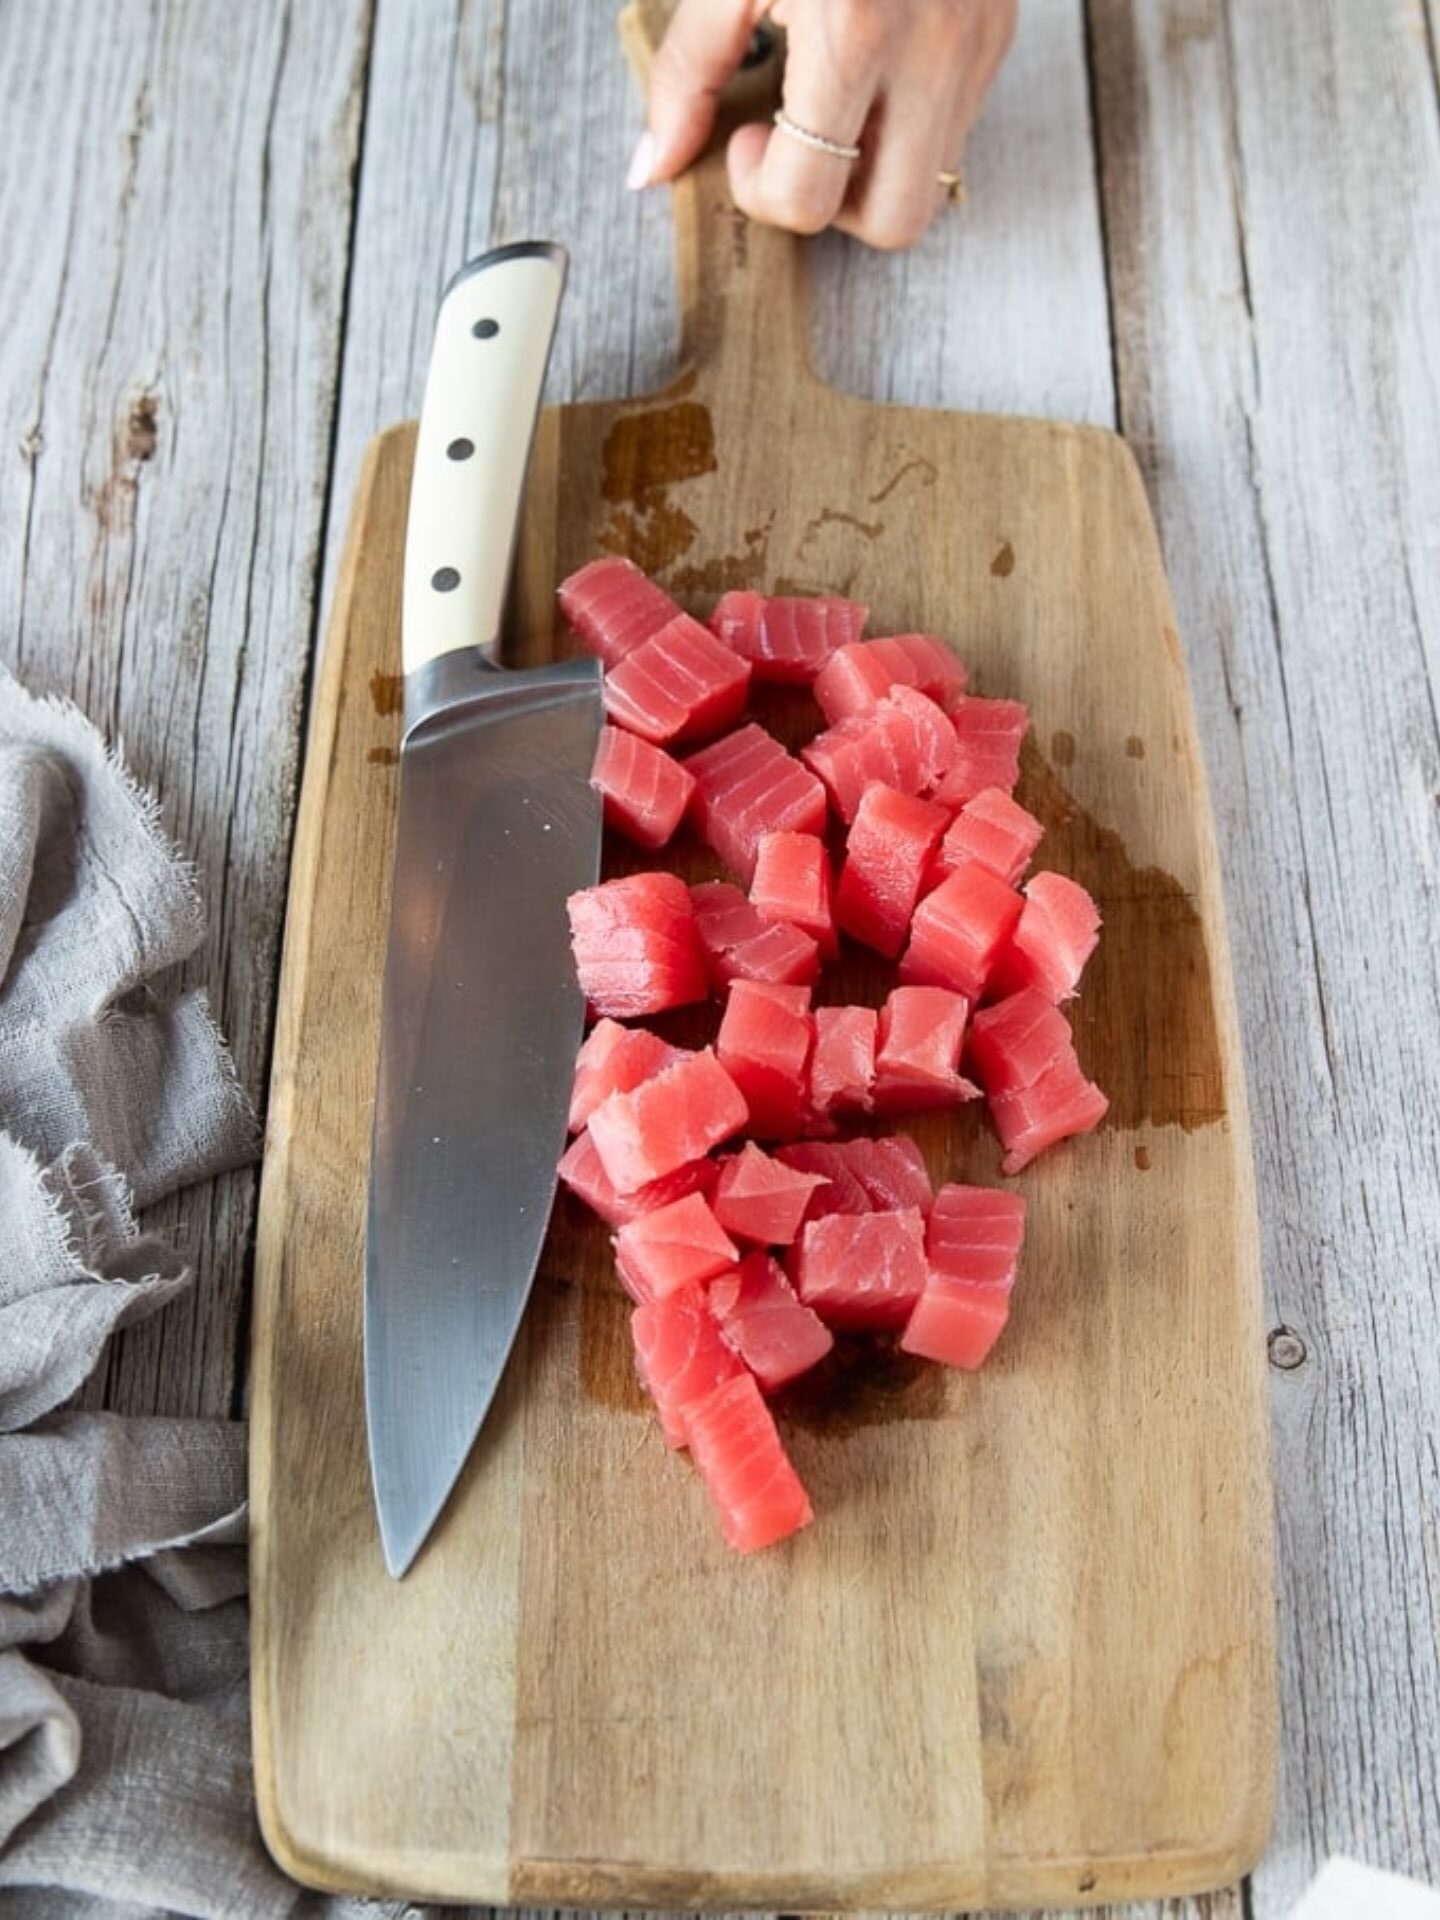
[730,0,885,234]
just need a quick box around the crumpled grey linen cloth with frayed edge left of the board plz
[0,668,407,1920]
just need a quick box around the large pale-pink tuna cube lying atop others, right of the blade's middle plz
[589,1044,756,1194]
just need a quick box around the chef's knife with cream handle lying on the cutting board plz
[365,242,601,1576]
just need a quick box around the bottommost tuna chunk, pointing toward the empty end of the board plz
[685,1373,814,1553]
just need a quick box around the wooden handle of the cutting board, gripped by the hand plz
[618,0,812,394]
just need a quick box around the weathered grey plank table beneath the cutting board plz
[0,0,1440,1920]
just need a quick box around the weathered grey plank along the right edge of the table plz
[1091,0,1440,1920]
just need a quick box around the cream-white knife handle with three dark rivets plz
[401,240,566,674]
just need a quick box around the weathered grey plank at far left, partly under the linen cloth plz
[0,0,367,1413]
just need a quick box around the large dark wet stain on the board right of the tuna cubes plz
[1018,741,1225,1128]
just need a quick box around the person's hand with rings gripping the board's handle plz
[628,0,1018,248]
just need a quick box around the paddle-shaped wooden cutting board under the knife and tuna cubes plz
[252,3,1275,1910]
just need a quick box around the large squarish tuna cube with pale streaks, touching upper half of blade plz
[564,874,710,1020]
